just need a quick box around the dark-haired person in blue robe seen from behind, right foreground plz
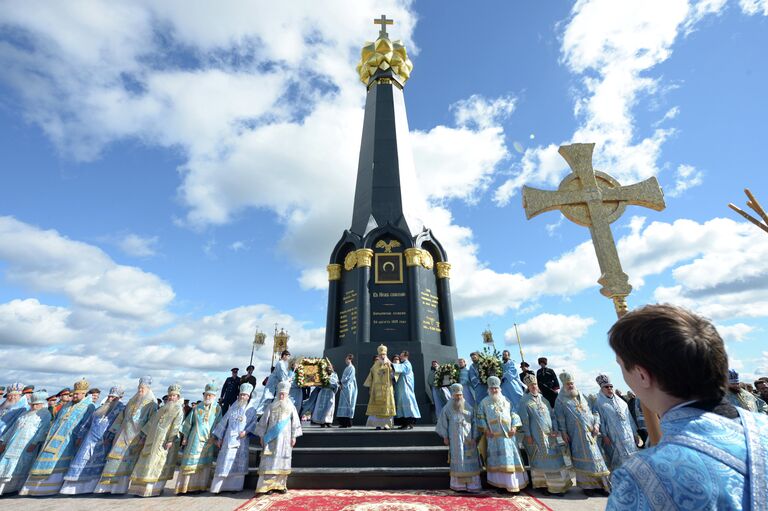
[607,305,768,511]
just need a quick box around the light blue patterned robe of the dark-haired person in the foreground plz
[607,406,768,511]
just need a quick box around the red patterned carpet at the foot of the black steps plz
[237,490,552,511]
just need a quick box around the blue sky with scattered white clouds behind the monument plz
[0,0,768,394]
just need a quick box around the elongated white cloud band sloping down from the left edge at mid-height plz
[0,216,174,324]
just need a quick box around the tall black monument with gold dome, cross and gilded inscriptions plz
[324,15,458,424]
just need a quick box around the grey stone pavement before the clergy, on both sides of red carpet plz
[0,489,607,511]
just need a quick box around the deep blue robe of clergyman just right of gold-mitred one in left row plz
[64,402,125,482]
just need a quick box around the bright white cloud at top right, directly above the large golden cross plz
[495,0,725,205]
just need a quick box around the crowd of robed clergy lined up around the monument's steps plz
[0,338,768,497]
